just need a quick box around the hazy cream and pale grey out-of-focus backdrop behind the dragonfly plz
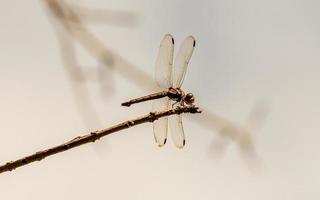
[0,0,320,200]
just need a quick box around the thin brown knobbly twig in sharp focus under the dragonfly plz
[0,106,201,173]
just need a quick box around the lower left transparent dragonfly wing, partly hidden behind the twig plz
[152,97,169,147]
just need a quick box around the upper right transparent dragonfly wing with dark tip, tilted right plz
[172,36,196,88]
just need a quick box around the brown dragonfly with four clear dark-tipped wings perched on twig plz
[121,34,196,148]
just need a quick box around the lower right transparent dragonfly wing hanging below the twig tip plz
[169,106,186,148]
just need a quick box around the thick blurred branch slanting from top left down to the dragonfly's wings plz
[45,0,155,89]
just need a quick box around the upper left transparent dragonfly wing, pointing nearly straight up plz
[155,34,174,88]
